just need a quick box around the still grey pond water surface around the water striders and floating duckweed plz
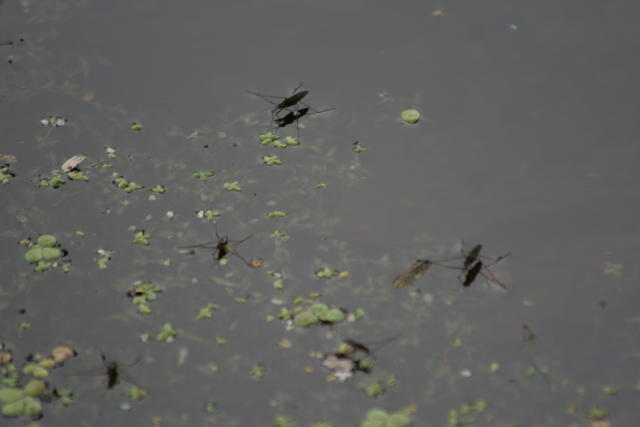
[0,0,640,426]
